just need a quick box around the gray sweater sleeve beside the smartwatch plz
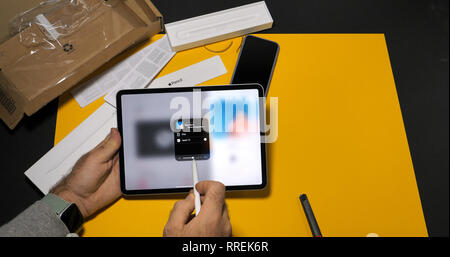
[0,201,69,237]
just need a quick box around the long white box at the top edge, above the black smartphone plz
[165,1,273,51]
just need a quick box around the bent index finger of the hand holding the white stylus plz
[195,181,225,216]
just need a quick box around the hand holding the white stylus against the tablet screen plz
[164,181,231,237]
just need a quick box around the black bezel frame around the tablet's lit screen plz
[116,84,267,195]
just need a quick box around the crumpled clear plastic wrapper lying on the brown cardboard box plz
[9,0,114,97]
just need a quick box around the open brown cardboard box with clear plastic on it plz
[0,0,163,129]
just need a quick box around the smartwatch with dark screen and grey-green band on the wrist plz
[42,193,84,233]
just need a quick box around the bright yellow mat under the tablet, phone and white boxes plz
[55,34,427,236]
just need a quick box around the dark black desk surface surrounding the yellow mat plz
[0,0,449,236]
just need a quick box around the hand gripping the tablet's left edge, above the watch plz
[51,128,121,218]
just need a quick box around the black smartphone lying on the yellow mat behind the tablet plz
[231,36,280,96]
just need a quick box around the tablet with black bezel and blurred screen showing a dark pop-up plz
[117,84,267,195]
